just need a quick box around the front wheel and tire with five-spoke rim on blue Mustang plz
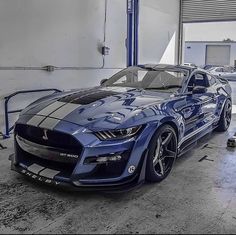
[146,125,178,182]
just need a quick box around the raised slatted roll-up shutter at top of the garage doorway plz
[182,0,236,23]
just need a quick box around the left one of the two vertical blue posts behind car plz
[126,0,134,67]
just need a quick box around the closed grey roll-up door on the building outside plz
[206,45,230,65]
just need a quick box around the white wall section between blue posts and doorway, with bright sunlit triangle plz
[139,0,180,64]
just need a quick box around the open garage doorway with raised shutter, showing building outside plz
[180,0,236,66]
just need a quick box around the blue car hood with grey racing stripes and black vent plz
[21,87,172,130]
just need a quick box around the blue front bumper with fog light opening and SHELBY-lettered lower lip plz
[11,123,157,192]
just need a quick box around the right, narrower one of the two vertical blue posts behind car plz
[133,0,139,65]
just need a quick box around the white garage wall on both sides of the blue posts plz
[0,0,179,134]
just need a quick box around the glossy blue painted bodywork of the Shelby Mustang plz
[11,66,231,191]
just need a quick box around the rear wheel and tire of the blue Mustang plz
[216,99,232,132]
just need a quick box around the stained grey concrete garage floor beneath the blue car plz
[0,83,236,233]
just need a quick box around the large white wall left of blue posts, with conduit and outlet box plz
[0,0,127,131]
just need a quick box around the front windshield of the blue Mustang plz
[103,67,188,92]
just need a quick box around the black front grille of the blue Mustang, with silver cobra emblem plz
[15,124,83,178]
